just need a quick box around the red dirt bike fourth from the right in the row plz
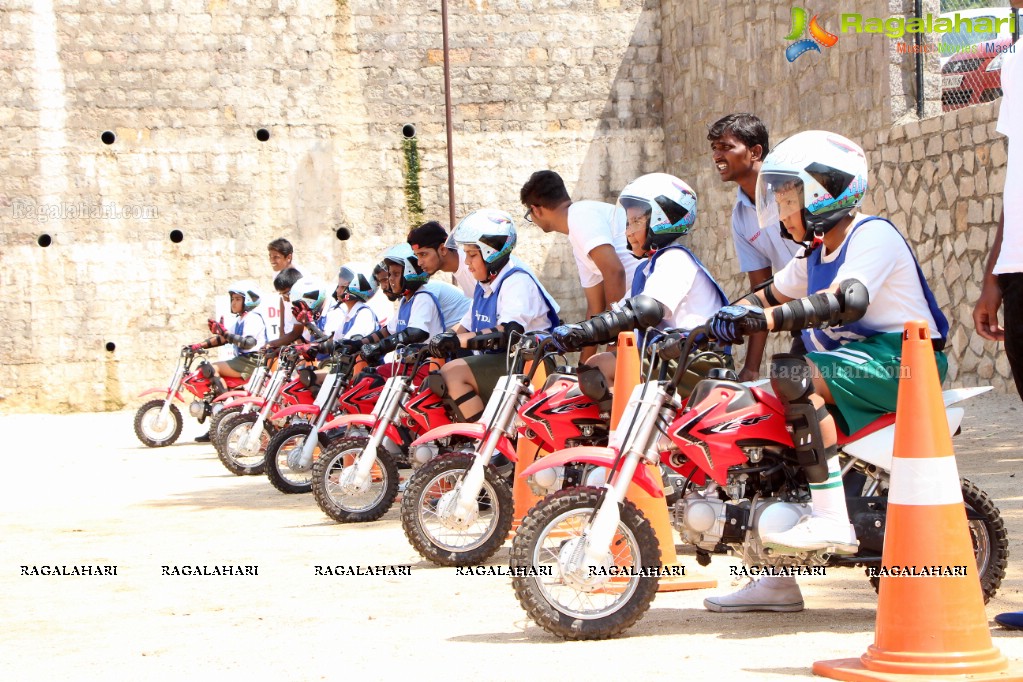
[264,349,366,494]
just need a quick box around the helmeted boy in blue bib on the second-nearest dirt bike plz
[554,173,728,385]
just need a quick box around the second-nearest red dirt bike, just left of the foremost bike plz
[401,333,610,565]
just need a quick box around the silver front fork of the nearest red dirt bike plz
[573,384,667,566]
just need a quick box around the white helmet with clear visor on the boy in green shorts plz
[756,130,866,242]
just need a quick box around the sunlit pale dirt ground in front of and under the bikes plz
[0,394,1023,681]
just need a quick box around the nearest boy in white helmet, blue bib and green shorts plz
[704,131,948,611]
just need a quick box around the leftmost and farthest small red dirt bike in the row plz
[135,347,244,448]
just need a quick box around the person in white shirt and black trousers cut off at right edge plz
[973,0,1023,630]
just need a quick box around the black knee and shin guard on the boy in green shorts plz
[770,354,838,484]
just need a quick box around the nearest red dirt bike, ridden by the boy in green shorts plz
[512,328,1009,639]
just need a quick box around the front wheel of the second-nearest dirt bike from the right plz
[401,453,515,566]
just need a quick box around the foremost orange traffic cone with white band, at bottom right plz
[813,321,1023,680]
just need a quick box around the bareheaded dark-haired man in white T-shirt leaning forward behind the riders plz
[519,171,639,361]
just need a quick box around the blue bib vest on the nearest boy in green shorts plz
[803,216,948,352]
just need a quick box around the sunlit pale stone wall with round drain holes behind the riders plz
[0,0,663,411]
